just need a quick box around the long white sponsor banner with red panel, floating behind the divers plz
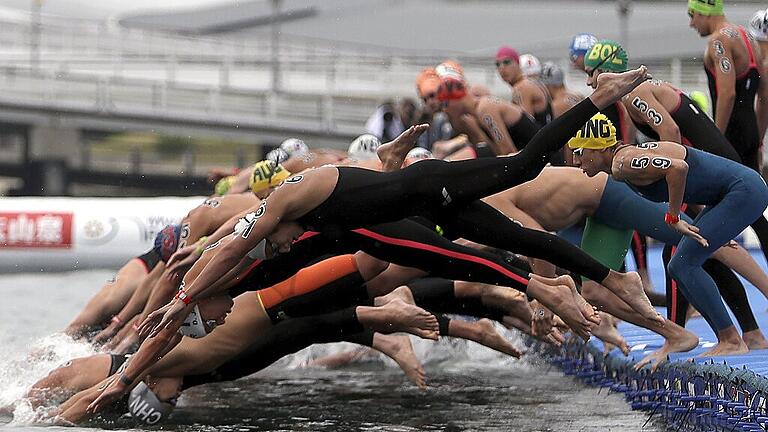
[0,197,205,272]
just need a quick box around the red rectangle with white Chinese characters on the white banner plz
[0,212,72,249]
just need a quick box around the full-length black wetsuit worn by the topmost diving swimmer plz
[298,98,610,289]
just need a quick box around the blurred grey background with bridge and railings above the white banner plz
[0,0,765,196]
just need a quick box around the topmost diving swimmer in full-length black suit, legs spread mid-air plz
[145,67,663,346]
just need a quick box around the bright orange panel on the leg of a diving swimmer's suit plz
[257,255,357,309]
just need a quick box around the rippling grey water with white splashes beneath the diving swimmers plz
[0,271,663,432]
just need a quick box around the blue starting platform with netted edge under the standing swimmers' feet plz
[540,249,768,432]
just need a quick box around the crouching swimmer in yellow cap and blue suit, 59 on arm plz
[569,112,768,355]
